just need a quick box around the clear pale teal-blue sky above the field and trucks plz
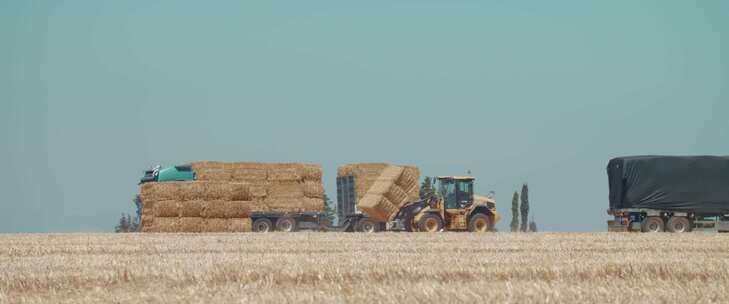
[0,0,729,232]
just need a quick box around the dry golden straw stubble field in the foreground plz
[0,232,729,303]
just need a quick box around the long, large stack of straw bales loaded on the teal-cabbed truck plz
[141,161,324,232]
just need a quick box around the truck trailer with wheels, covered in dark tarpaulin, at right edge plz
[607,155,729,233]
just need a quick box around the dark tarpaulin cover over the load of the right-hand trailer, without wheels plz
[607,156,729,214]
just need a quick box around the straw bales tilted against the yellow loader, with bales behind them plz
[337,163,420,222]
